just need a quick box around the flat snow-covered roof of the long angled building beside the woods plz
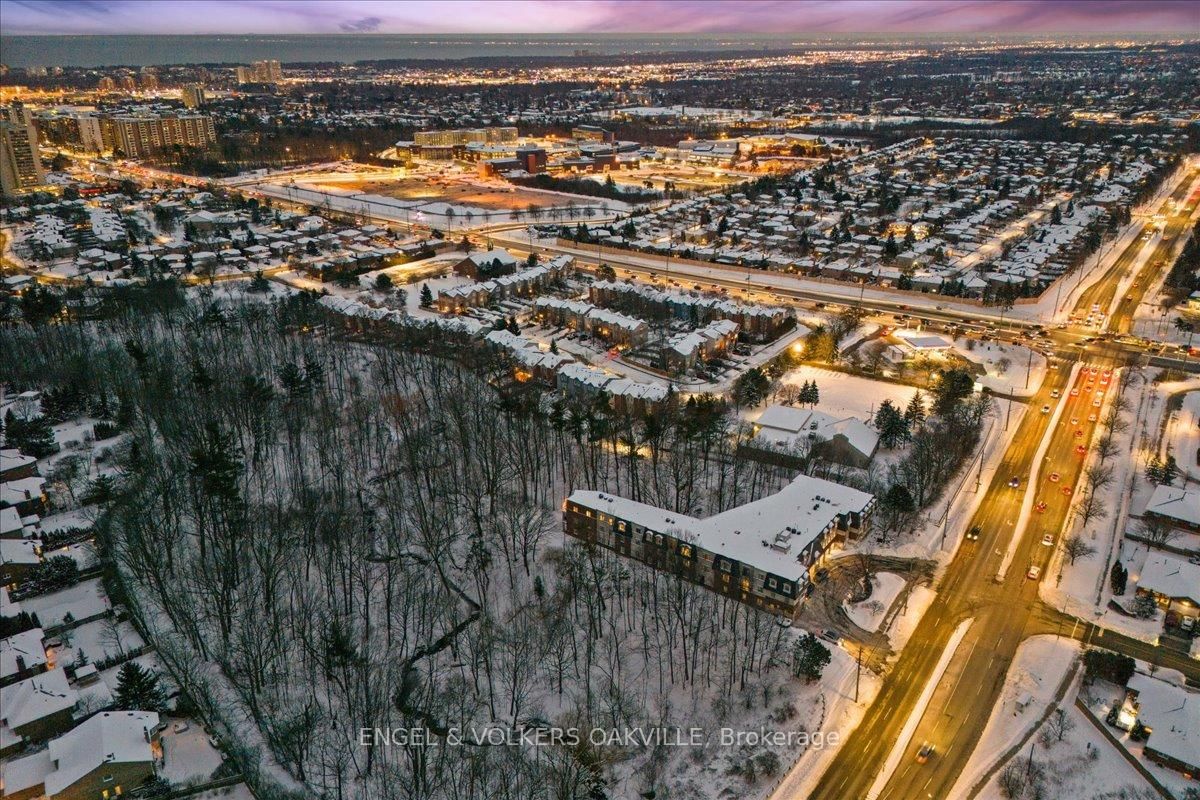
[568,475,875,579]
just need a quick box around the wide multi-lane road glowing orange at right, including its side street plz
[796,164,1200,800]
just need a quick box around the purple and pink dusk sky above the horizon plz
[0,0,1200,37]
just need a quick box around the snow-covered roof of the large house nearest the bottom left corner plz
[46,711,158,798]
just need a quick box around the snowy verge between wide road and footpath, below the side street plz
[950,636,1080,798]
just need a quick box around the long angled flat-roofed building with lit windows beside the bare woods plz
[563,475,875,616]
